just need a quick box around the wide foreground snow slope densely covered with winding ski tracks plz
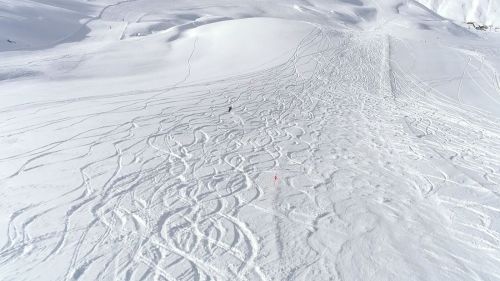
[0,25,500,280]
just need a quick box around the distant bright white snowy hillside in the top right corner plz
[417,0,500,27]
